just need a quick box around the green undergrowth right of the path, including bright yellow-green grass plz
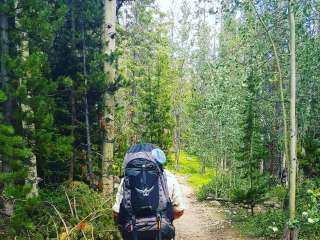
[167,152,320,240]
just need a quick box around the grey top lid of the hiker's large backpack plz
[123,143,157,168]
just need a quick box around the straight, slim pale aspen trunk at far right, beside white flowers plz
[289,0,297,221]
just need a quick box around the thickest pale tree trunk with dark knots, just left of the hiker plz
[101,0,117,195]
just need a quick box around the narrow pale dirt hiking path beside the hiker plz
[175,176,247,240]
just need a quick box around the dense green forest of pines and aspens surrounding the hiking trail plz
[0,0,320,240]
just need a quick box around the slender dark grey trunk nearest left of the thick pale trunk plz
[82,22,93,184]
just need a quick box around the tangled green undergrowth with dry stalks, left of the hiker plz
[0,182,119,240]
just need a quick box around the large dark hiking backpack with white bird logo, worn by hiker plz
[119,144,175,240]
